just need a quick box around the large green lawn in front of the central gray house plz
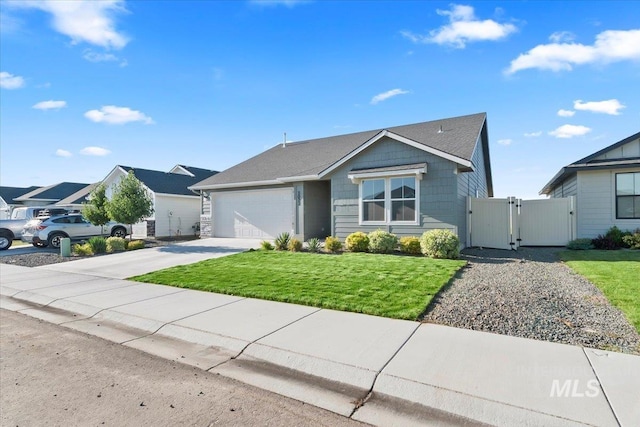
[133,251,465,320]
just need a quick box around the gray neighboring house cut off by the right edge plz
[540,132,640,238]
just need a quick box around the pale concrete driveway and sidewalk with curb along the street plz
[0,239,640,426]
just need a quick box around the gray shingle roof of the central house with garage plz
[194,113,486,188]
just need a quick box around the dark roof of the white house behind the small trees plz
[120,165,218,196]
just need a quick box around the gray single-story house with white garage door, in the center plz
[191,113,493,242]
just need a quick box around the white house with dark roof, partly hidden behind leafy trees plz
[102,165,217,237]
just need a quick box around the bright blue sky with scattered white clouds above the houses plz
[0,0,640,198]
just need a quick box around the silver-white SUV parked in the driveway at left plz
[22,214,131,248]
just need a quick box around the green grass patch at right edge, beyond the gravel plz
[560,250,640,332]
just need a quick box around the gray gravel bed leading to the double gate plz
[423,248,640,354]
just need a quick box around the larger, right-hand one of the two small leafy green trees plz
[107,171,153,239]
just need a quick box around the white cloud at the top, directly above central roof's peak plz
[401,4,518,49]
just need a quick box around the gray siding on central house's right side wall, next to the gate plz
[456,136,489,245]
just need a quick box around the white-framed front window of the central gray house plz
[360,176,418,224]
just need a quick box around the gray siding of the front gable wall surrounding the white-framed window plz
[331,139,466,239]
